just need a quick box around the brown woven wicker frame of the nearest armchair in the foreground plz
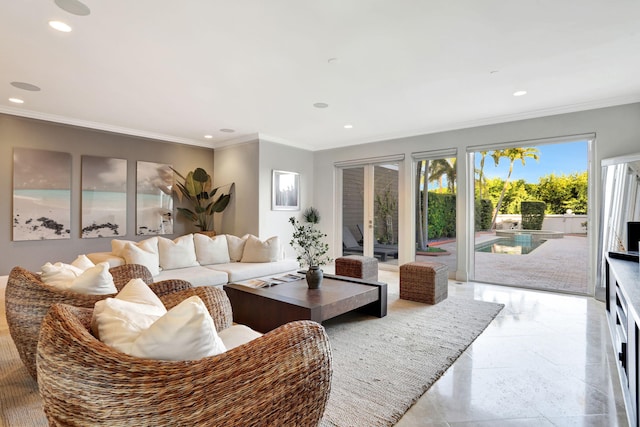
[37,287,332,427]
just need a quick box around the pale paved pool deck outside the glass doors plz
[416,233,589,294]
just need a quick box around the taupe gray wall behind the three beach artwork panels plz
[0,114,215,275]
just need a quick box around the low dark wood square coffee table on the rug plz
[224,274,387,332]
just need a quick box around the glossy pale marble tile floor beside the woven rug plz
[360,271,628,427]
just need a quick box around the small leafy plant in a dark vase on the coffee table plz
[289,207,332,289]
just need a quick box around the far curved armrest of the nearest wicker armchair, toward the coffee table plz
[160,286,233,331]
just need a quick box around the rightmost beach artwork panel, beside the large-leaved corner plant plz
[136,162,173,235]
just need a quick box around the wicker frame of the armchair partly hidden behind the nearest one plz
[5,264,191,380]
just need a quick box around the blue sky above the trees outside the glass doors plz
[475,141,587,184]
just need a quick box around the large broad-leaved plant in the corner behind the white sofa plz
[171,168,233,236]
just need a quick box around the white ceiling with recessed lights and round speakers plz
[0,0,640,150]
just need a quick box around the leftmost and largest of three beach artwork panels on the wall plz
[12,147,71,241]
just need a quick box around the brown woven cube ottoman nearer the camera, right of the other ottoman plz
[400,262,449,304]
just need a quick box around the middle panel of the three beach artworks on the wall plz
[81,156,127,239]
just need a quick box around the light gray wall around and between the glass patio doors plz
[314,103,640,292]
